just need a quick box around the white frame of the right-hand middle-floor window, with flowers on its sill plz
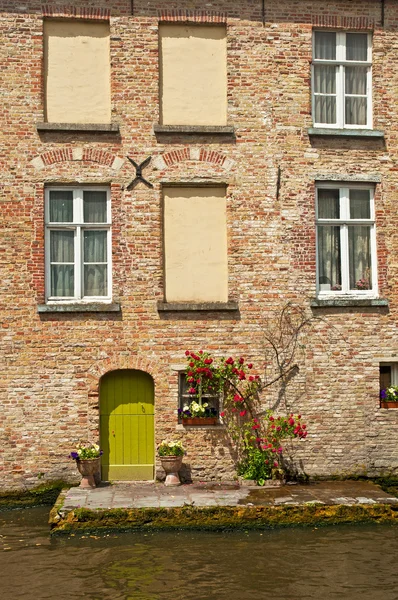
[316,182,378,298]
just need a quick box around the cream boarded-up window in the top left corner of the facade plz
[44,20,111,123]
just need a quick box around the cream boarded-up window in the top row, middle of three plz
[159,24,227,125]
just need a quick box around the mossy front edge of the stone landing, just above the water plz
[53,504,398,533]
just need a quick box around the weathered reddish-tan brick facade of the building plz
[0,0,398,489]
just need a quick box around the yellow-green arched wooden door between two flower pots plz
[100,369,155,481]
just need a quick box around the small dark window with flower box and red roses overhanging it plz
[178,350,220,427]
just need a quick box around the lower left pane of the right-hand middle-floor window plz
[318,226,341,291]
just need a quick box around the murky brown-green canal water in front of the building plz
[0,508,398,600]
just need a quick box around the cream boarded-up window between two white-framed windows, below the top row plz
[164,187,228,302]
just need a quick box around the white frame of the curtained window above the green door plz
[44,186,112,304]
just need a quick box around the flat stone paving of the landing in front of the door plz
[62,481,398,514]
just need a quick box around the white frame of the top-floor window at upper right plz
[311,29,373,129]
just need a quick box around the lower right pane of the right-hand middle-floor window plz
[348,225,372,290]
